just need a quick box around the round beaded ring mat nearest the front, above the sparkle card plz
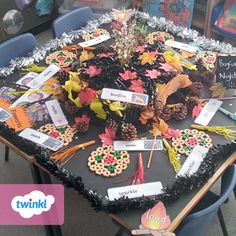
[88,146,130,177]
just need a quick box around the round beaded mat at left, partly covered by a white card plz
[38,124,76,146]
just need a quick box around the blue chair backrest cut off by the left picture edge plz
[0,33,38,67]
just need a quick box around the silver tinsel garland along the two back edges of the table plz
[0,11,236,78]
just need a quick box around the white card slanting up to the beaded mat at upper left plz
[27,64,61,89]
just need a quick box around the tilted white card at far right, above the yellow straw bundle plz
[194,99,222,126]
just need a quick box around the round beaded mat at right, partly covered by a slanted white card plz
[172,129,212,155]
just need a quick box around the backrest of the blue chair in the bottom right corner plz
[176,165,236,236]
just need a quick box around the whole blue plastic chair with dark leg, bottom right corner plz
[176,165,236,236]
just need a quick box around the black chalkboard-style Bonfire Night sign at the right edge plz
[216,55,236,88]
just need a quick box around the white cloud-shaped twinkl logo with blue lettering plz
[11,190,55,218]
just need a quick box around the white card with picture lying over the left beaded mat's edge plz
[19,128,64,151]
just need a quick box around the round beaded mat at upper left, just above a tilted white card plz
[46,51,76,67]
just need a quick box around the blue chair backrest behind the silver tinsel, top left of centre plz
[52,7,94,38]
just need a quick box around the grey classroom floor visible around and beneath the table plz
[0,30,236,236]
